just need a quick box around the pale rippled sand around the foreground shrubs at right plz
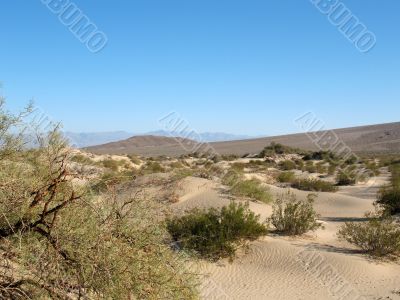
[172,174,400,299]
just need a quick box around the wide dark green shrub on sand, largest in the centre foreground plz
[167,202,267,260]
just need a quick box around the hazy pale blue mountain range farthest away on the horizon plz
[64,130,251,148]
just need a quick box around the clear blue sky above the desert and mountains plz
[0,0,400,135]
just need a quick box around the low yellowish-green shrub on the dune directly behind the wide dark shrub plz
[230,179,272,203]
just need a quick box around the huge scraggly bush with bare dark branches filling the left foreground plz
[0,101,196,299]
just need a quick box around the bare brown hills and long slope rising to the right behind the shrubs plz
[86,122,400,156]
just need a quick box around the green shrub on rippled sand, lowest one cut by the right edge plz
[338,214,400,256]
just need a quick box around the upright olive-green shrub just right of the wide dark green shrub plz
[268,192,322,235]
